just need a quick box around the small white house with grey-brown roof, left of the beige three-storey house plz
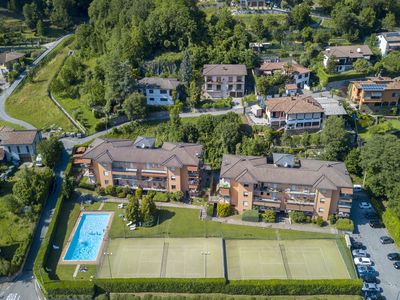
[139,77,180,106]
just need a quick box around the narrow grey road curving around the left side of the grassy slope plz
[0,34,69,129]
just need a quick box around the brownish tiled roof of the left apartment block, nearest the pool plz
[82,139,203,167]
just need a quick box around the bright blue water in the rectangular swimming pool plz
[64,213,111,260]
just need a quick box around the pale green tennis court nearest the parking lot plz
[225,240,350,280]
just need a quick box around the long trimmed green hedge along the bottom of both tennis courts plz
[94,278,362,295]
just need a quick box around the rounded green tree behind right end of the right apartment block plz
[321,116,348,160]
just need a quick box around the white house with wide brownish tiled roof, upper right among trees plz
[323,45,372,73]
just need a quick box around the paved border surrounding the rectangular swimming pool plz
[58,210,114,265]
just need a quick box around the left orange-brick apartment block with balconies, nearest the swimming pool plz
[82,137,203,195]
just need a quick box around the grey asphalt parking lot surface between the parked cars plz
[352,192,400,300]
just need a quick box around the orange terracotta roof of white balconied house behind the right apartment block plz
[265,96,324,114]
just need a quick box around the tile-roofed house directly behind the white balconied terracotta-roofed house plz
[260,61,311,89]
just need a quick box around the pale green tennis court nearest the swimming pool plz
[97,238,224,278]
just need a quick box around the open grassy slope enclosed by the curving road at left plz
[6,37,76,131]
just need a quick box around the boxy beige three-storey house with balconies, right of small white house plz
[203,65,247,99]
